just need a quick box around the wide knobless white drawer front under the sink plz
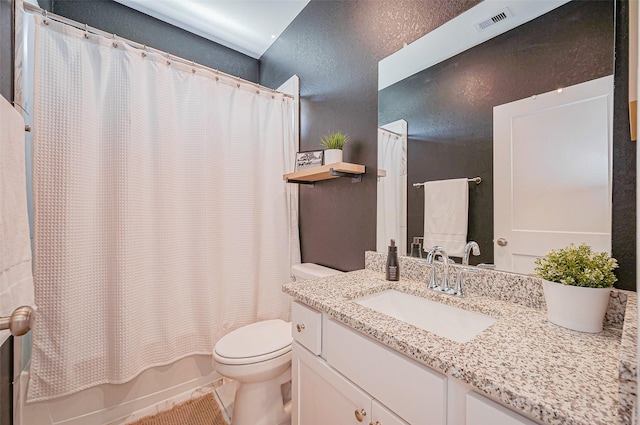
[324,320,444,425]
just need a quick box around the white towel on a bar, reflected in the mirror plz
[424,178,469,257]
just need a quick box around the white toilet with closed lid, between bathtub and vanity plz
[213,263,342,425]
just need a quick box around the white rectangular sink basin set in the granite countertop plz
[353,289,496,343]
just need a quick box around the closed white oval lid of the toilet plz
[214,319,293,359]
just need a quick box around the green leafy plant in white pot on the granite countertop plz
[535,242,618,333]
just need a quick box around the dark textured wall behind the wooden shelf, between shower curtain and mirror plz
[260,0,479,271]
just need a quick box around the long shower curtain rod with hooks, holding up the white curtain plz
[23,3,294,99]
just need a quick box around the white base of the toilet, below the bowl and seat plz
[231,367,291,425]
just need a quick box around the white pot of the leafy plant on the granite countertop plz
[542,280,611,333]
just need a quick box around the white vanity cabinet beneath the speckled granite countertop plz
[292,301,535,425]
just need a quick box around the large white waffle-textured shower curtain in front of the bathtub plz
[28,16,300,401]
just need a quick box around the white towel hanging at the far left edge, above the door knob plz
[0,96,33,344]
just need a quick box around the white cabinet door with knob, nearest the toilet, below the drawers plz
[292,342,371,425]
